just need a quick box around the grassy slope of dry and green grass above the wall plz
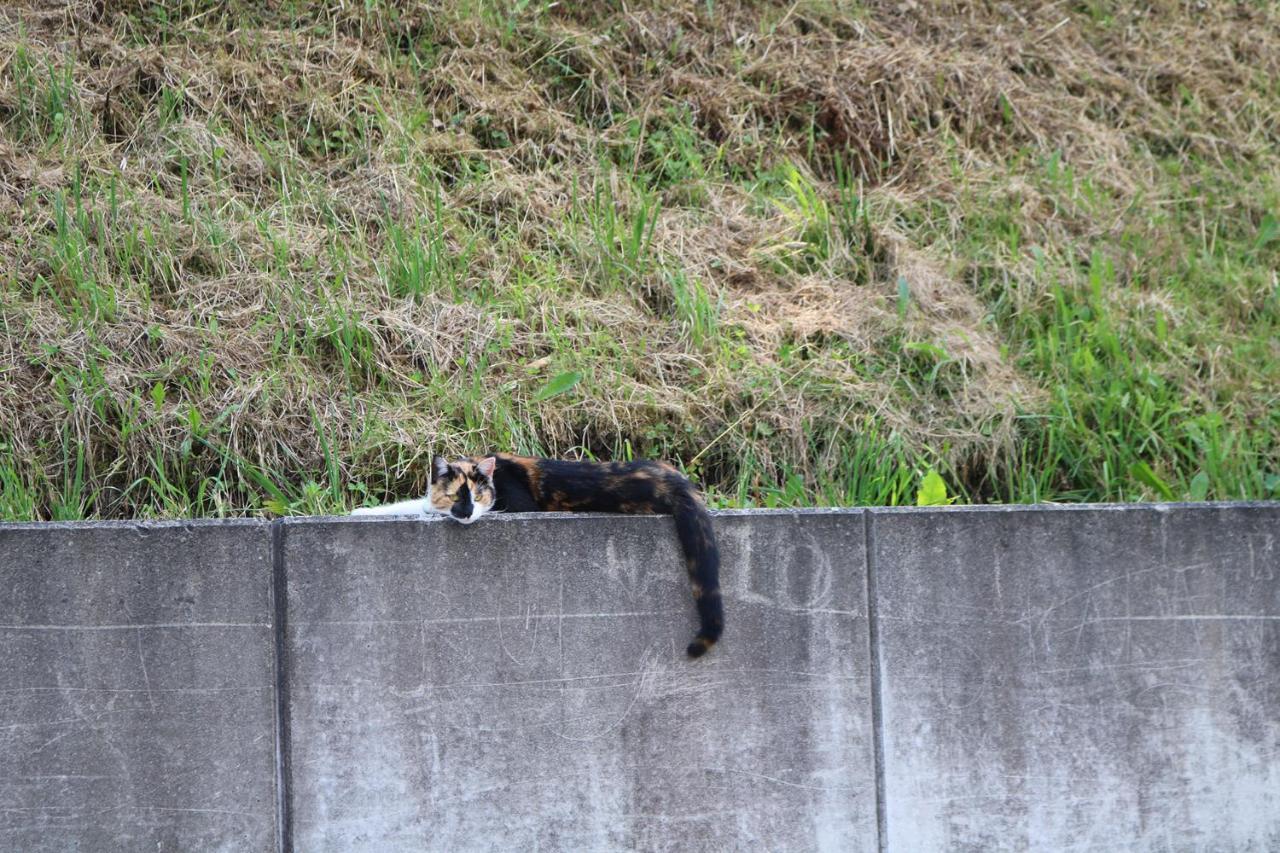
[0,0,1280,519]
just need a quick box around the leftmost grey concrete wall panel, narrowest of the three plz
[0,523,275,852]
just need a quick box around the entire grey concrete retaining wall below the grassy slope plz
[0,505,1280,850]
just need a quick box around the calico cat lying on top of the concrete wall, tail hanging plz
[353,453,724,657]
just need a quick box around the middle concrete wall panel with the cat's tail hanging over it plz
[284,512,877,850]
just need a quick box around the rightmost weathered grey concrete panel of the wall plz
[872,505,1280,850]
